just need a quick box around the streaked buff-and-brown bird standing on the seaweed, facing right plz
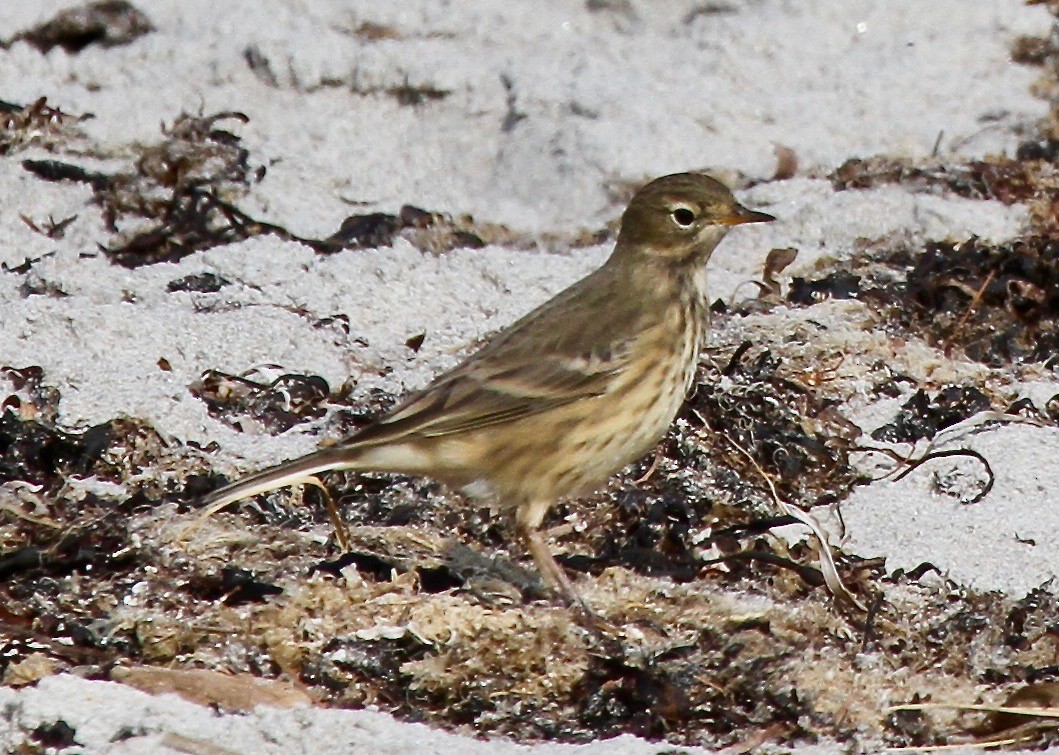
[199,173,774,605]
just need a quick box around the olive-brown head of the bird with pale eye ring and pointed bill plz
[614,173,775,265]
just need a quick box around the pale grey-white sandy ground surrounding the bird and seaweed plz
[0,0,1059,753]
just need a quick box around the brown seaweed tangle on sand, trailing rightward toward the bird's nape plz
[20,109,542,267]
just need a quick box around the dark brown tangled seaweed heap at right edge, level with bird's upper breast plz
[897,236,1059,366]
